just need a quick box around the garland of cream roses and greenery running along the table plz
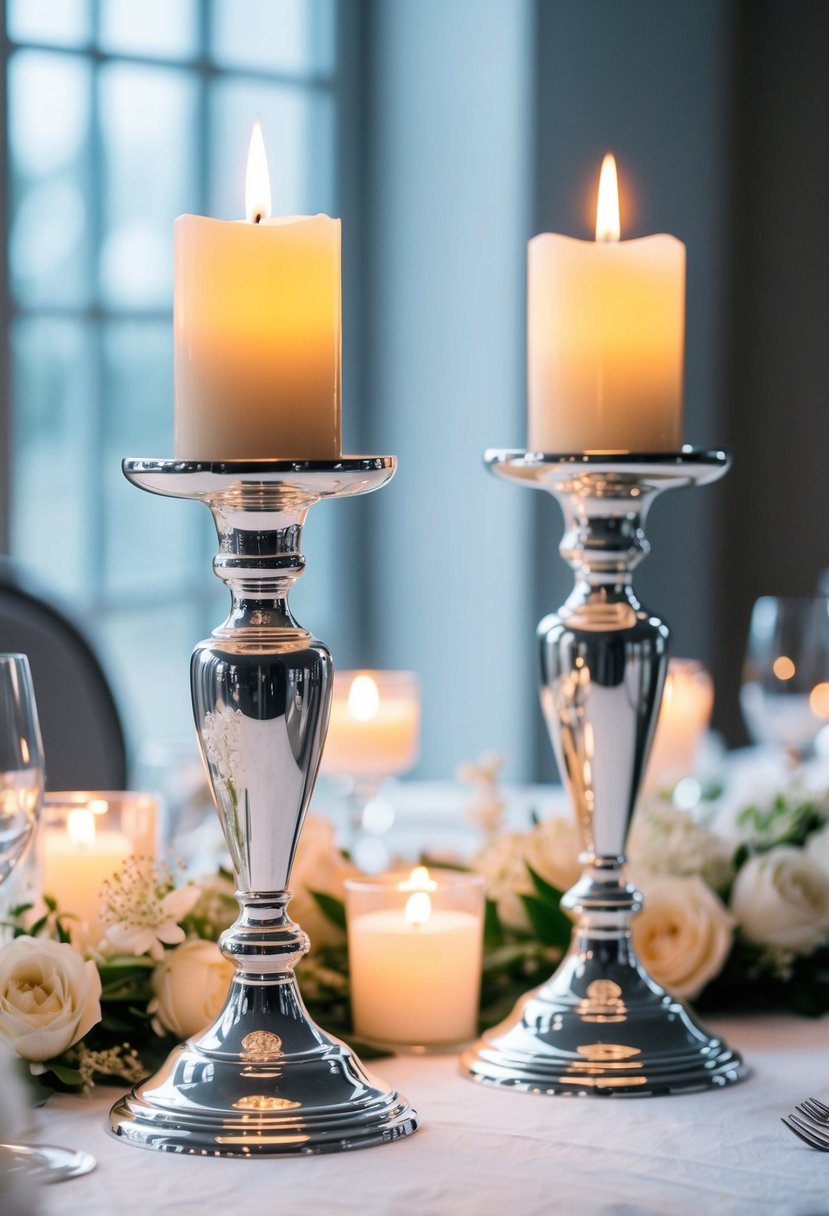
[0,783,829,1091]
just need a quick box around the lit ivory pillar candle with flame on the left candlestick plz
[174,126,342,460]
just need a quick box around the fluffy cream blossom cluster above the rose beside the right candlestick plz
[627,799,733,888]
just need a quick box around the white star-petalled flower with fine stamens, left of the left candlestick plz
[101,858,201,959]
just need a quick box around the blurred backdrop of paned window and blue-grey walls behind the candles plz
[0,0,829,781]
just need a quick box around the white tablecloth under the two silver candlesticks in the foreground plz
[19,1017,829,1216]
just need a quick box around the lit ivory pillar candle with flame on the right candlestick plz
[528,157,686,452]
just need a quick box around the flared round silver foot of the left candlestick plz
[111,976,417,1156]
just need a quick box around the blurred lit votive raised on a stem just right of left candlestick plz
[322,671,421,777]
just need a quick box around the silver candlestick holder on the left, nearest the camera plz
[111,456,417,1156]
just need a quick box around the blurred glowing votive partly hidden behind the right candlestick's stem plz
[645,659,714,790]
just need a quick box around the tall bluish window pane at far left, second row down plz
[9,51,91,304]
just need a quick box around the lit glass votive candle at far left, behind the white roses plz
[38,790,157,941]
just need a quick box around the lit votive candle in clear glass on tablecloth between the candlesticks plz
[345,866,484,1051]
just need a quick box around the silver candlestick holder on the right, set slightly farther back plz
[462,449,744,1096]
